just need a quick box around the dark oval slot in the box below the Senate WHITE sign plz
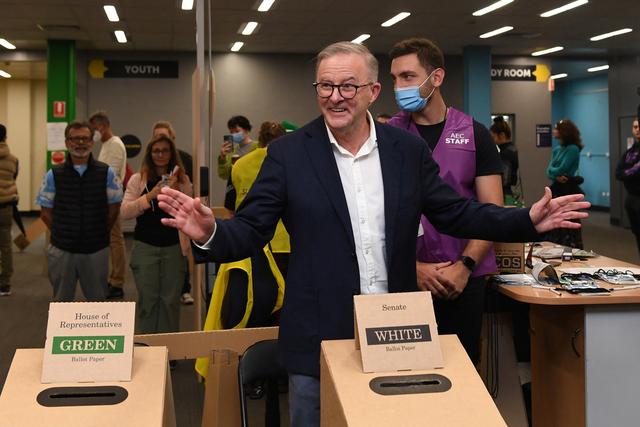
[369,374,451,395]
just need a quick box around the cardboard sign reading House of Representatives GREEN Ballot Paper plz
[42,302,136,383]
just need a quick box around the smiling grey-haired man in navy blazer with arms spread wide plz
[159,42,589,426]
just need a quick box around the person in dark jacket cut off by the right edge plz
[616,119,640,252]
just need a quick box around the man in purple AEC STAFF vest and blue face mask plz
[388,38,503,363]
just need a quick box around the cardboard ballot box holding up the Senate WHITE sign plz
[320,335,506,427]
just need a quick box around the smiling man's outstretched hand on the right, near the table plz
[529,187,591,233]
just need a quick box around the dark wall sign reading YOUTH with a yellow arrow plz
[89,59,178,79]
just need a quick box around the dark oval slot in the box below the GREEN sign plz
[36,386,129,407]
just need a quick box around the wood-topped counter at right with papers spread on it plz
[498,251,640,427]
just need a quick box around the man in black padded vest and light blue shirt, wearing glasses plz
[36,122,122,301]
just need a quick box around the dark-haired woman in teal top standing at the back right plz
[547,119,584,249]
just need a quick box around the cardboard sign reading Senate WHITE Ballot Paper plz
[353,292,444,372]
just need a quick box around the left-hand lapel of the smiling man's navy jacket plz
[304,116,355,250]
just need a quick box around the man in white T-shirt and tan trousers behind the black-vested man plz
[89,111,127,299]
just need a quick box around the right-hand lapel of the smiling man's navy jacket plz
[375,123,402,263]
